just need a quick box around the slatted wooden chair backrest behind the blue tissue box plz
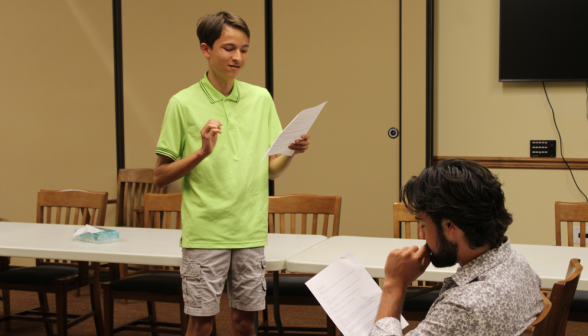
[37,189,108,271]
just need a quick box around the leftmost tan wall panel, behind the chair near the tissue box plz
[0,0,116,234]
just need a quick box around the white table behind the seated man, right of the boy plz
[286,236,588,290]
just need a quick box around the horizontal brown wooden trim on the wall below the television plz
[433,156,588,170]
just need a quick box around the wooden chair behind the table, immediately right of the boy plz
[259,194,341,335]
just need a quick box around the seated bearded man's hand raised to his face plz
[384,244,431,289]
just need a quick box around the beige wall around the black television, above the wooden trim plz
[435,0,588,158]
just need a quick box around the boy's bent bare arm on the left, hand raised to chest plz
[153,119,223,188]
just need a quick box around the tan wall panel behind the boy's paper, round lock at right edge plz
[274,0,399,237]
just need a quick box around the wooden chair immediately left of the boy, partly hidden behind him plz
[102,193,216,336]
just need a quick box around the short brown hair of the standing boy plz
[196,11,250,49]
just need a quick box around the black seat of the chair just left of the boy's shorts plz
[110,273,182,295]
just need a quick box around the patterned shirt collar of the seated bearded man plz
[451,237,511,286]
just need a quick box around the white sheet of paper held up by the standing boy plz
[261,102,327,161]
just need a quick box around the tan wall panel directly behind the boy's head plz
[122,0,265,192]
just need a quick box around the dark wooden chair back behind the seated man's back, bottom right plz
[545,259,583,336]
